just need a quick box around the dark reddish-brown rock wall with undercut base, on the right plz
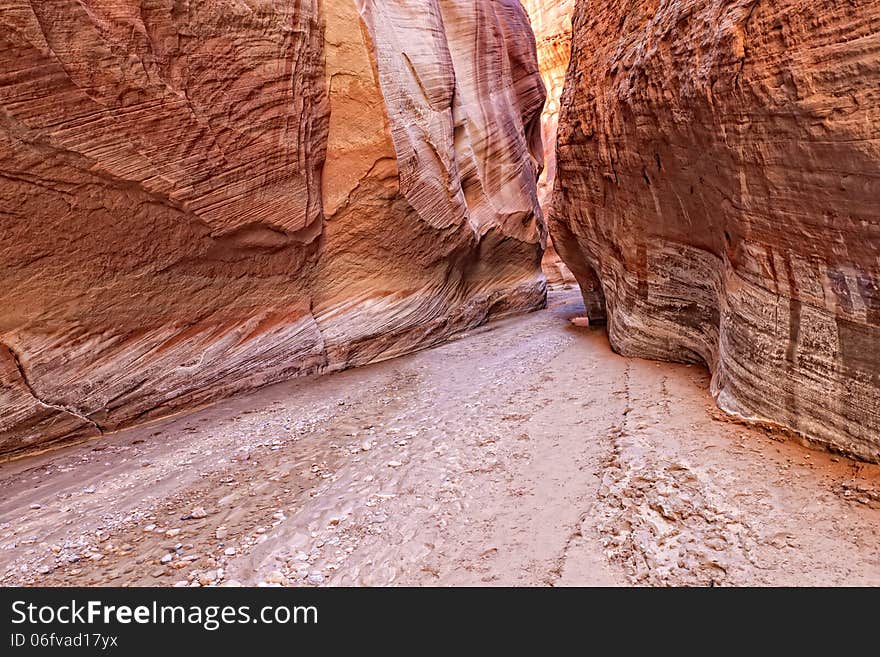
[550,0,880,461]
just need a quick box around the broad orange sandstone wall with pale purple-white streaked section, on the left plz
[0,0,545,453]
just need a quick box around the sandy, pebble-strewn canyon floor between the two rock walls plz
[0,290,880,586]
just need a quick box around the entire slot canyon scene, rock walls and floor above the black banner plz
[0,0,880,587]
